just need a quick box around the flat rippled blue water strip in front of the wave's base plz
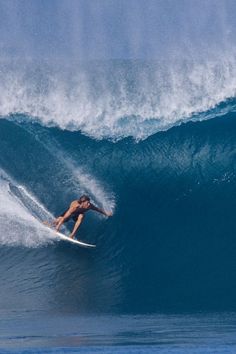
[0,311,236,353]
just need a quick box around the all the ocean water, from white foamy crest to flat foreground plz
[0,48,236,353]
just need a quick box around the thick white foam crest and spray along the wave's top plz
[0,54,236,139]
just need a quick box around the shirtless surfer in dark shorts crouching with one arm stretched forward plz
[53,195,112,238]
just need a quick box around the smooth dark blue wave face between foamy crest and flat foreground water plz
[0,101,236,313]
